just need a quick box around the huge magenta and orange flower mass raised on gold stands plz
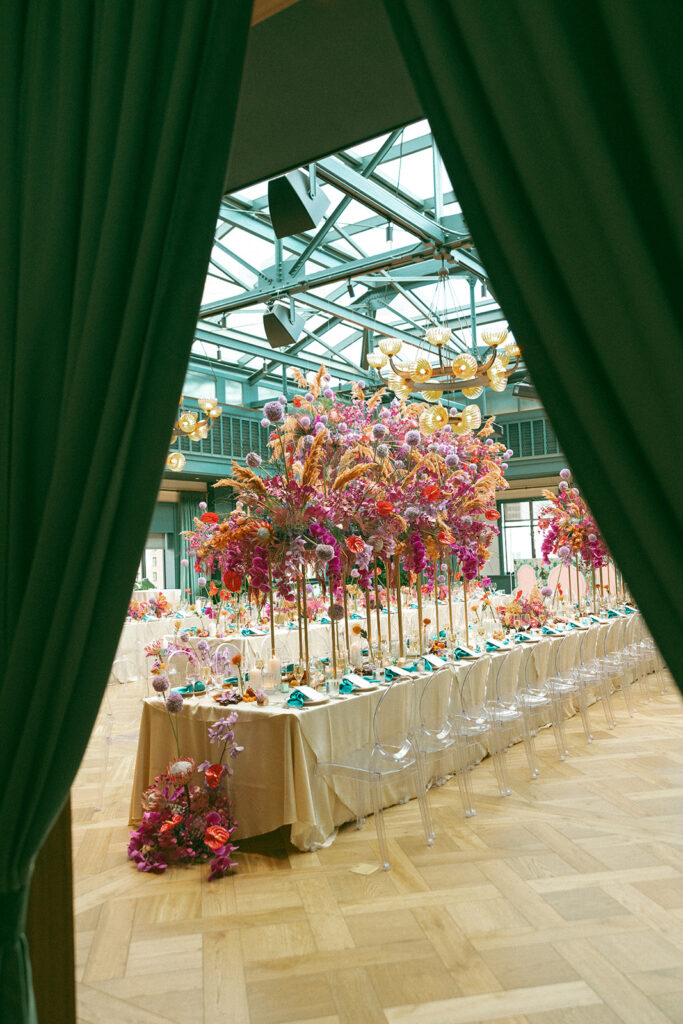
[185,367,512,606]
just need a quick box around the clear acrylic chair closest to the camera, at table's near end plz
[314,680,434,871]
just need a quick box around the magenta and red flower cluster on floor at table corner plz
[128,676,244,882]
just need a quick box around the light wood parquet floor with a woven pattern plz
[73,671,683,1024]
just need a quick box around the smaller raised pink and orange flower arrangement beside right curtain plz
[539,469,608,569]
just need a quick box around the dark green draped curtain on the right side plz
[385,0,683,688]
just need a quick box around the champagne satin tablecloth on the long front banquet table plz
[130,626,630,850]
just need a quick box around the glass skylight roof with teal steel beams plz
[193,121,505,389]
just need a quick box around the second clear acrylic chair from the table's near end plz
[415,665,476,817]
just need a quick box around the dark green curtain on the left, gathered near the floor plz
[0,0,251,1024]
